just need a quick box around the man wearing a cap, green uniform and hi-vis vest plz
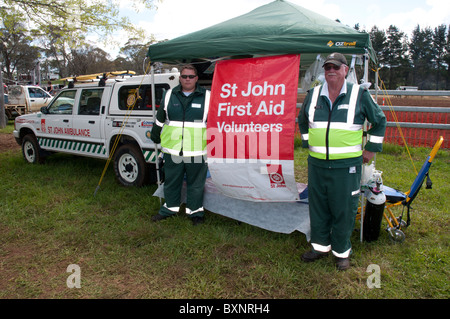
[298,53,386,270]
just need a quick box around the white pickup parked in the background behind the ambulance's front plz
[5,85,53,119]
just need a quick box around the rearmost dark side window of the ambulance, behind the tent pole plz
[119,84,170,111]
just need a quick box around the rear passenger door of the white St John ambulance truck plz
[73,87,109,157]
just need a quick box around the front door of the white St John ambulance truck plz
[38,90,77,152]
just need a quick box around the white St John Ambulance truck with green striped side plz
[13,72,179,186]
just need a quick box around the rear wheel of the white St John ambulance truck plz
[114,144,147,187]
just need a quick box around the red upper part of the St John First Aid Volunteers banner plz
[208,55,300,160]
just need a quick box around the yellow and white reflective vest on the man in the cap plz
[308,85,363,160]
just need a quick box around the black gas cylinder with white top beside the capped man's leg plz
[363,187,386,242]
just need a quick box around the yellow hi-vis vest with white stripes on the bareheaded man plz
[157,89,210,156]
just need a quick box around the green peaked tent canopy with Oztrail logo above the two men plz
[147,0,376,64]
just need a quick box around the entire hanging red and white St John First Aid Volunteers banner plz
[207,55,300,201]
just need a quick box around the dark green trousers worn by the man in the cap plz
[308,163,361,258]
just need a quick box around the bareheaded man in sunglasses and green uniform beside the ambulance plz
[151,65,209,225]
